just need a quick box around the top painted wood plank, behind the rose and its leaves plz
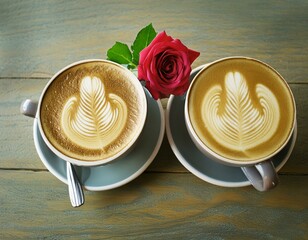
[0,0,308,82]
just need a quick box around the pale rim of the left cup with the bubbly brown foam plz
[36,58,148,166]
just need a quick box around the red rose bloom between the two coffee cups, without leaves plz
[138,32,200,99]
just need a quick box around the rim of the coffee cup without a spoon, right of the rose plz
[184,56,297,166]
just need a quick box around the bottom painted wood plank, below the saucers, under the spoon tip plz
[0,170,308,239]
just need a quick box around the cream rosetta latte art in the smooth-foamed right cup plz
[201,72,280,152]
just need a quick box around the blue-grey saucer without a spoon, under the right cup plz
[166,65,297,187]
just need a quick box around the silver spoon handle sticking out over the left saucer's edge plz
[66,162,84,207]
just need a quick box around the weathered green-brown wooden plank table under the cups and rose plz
[0,0,308,239]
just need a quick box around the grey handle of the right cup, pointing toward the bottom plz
[241,160,279,192]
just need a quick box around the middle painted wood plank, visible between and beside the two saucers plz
[0,79,308,173]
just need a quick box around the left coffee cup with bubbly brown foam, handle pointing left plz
[21,59,147,166]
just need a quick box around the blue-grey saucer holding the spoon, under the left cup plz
[33,89,165,191]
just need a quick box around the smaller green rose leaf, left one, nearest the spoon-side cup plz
[107,42,135,66]
